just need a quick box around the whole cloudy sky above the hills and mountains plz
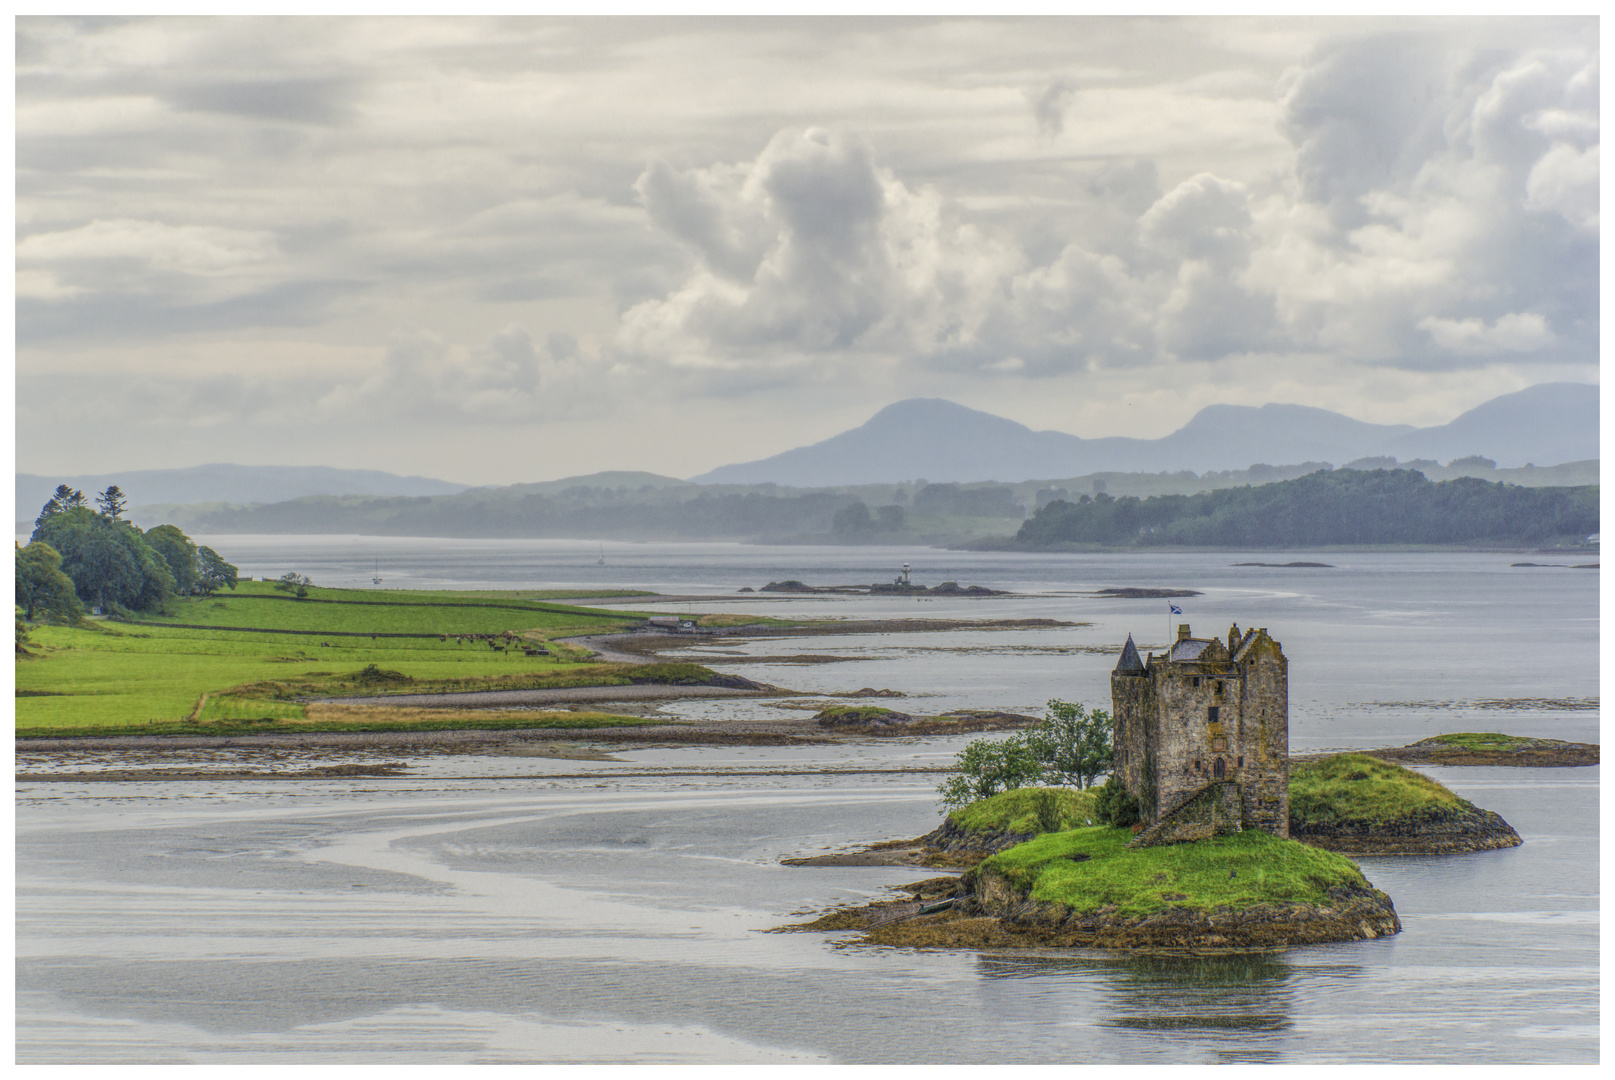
[16,18,1599,483]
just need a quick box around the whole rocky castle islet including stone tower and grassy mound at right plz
[782,626,1520,952]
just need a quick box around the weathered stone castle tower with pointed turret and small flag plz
[1111,623,1290,844]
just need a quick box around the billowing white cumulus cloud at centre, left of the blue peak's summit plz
[620,129,1016,366]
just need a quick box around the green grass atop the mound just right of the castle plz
[1290,749,1470,828]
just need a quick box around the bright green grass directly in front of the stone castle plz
[974,827,1368,917]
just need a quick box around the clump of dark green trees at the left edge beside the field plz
[16,484,237,622]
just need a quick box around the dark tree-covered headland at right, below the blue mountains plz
[1008,468,1599,550]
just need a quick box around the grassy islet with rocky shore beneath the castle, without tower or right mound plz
[787,788,1402,951]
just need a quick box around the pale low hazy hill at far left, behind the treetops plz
[16,465,470,521]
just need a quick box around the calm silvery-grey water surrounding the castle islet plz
[16,538,1599,1064]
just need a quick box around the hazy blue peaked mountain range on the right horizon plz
[693,383,1599,488]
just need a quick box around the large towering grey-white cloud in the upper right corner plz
[1274,36,1597,370]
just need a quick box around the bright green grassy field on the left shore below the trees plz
[16,583,698,736]
